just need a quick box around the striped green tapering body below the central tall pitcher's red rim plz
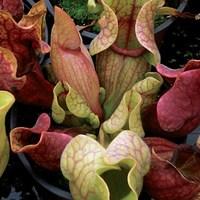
[96,49,150,119]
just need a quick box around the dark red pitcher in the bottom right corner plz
[144,138,200,200]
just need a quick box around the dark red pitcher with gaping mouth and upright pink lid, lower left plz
[10,113,72,170]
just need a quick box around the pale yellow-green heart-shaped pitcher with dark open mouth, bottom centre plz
[61,131,150,200]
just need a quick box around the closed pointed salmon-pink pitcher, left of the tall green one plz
[51,7,102,117]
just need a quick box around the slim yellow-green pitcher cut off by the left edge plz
[0,90,15,177]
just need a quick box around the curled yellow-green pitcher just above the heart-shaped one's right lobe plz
[100,73,163,143]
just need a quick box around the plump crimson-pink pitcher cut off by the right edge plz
[143,60,200,137]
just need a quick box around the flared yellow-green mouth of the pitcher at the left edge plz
[0,90,15,111]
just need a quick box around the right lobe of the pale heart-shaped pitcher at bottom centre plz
[105,131,151,199]
